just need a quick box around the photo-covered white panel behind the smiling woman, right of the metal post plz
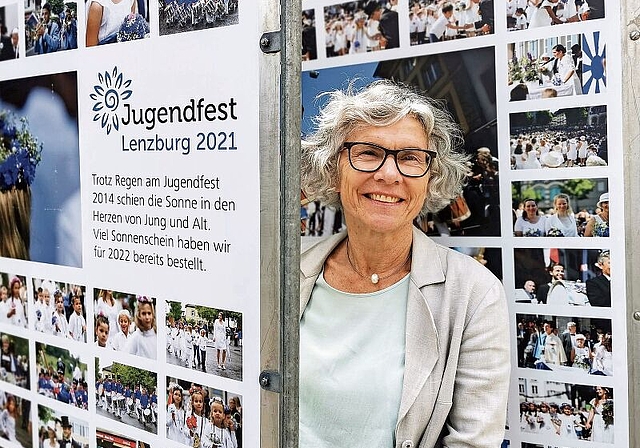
[300,0,626,448]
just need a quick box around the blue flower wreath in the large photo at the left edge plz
[0,111,42,191]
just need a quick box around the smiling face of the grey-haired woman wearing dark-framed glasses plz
[337,117,429,233]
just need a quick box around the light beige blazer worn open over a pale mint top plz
[300,228,511,448]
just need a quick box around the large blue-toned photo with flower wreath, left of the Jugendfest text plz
[0,72,82,267]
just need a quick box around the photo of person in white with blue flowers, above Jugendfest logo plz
[84,0,151,47]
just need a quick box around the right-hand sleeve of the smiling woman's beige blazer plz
[443,279,511,448]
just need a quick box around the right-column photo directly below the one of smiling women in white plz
[514,248,611,307]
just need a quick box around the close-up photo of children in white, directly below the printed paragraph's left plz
[93,289,158,359]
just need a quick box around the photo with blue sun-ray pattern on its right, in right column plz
[507,31,607,101]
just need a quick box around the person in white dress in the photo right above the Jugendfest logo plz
[86,0,136,47]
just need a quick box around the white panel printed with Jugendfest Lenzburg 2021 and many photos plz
[0,0,261,447]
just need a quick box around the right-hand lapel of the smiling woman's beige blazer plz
[398,228,445,420]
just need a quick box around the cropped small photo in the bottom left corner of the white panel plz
[0,389,33,448]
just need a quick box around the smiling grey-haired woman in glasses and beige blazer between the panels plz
[300,81,509,447]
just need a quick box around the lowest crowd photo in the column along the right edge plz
[518,378,614,443]
